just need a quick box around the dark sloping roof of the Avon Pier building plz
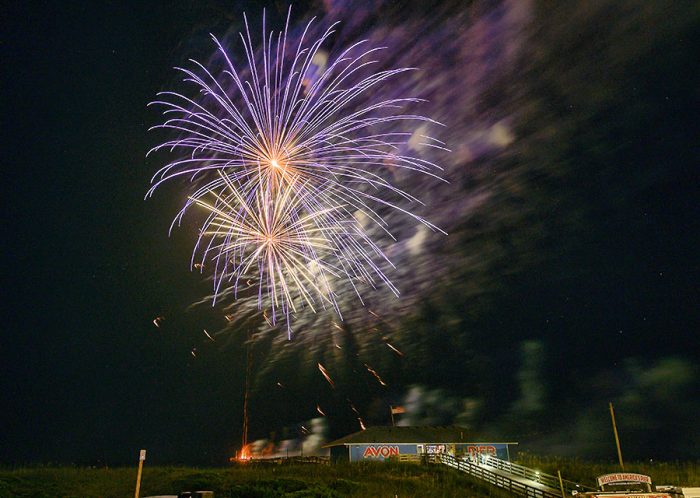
[323,425,514,448]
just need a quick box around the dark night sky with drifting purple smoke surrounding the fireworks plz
[0,0,700,465]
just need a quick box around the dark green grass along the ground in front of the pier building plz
[0,460,700,498]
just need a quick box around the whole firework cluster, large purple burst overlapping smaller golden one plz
[147,6,447,326]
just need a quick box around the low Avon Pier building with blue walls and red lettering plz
[324,426,517,462]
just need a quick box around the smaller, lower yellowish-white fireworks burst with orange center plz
[192,171,398,334]
